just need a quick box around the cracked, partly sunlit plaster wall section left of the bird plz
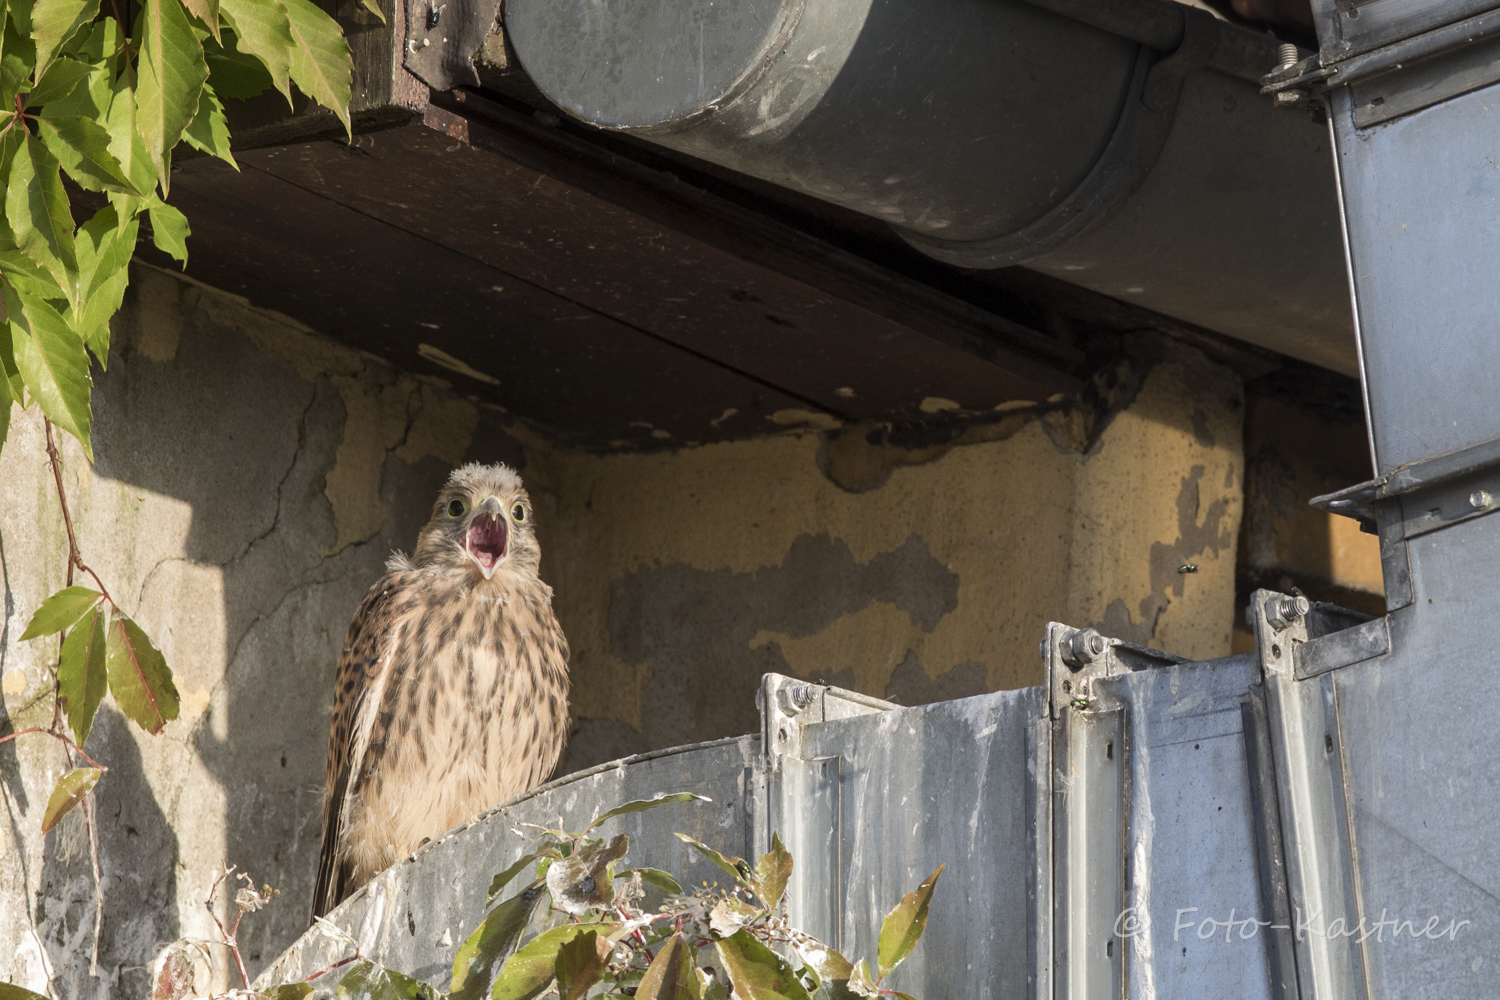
[0,268,519,997]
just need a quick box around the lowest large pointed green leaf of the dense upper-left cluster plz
[6,289,93,462]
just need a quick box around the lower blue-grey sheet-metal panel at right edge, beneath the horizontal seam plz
[1323,517,1500,1000]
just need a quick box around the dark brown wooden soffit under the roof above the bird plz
[144,89,1104,448]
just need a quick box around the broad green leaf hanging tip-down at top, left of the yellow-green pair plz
[135,0,209,193]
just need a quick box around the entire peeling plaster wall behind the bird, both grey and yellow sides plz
[0,268,1278,997]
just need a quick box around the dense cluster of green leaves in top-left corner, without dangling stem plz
[0,0,366,457]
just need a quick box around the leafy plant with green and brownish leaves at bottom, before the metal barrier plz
[294,793,944,1000]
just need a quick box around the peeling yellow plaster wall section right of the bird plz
[546,346,1244,766]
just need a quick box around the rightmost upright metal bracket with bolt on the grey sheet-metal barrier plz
[1247,591,1365,1000]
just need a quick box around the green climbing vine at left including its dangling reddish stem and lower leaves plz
[0,0,360,983]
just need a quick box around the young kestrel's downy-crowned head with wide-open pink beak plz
[414,462,542,580]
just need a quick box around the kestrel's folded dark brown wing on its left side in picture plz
[312,573,407,918]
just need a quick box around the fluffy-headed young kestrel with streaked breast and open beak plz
[312,465,569,916]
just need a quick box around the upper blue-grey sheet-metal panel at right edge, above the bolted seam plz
[1329,78,1500,474]
